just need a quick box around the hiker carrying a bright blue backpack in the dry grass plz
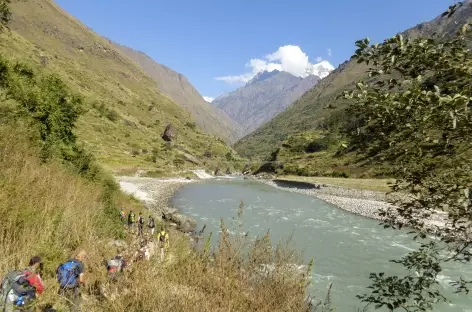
[56,250,87,311]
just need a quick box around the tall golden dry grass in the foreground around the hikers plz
[0,122,324,312]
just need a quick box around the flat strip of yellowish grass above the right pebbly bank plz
[280,176,394,192]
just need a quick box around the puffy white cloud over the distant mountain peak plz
[215,45,331,84]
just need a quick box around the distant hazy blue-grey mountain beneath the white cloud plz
[212,69,320,139]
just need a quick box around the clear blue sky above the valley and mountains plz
[56,0,453,97]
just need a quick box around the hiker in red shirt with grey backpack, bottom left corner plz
[0,256,44,312]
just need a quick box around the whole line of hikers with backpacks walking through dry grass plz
[0,209,169,312]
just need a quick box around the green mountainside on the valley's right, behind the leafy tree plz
[234,0,472,158]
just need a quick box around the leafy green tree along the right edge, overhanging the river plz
[344,3,472,311]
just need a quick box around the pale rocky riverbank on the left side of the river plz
[116,176,198,233]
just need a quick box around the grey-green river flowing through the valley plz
[173,178,472,312]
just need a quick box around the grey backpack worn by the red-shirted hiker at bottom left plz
[0,270,36,307]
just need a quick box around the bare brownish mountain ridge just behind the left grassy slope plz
[110,41,240,142]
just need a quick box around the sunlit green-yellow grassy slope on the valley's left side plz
[0,0,236,170]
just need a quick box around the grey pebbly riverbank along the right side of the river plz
[263,179,446,231]
